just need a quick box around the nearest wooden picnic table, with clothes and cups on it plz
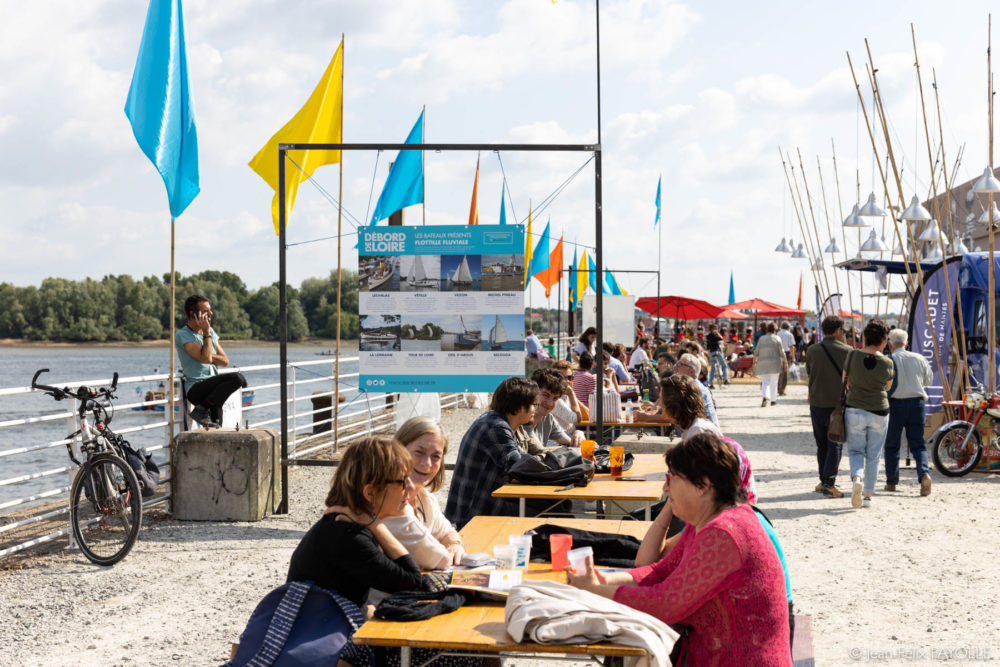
[353,516,650,667]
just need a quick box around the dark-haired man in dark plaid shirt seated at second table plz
[444,377,538,529]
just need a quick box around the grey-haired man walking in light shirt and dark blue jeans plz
[885,329,934,496]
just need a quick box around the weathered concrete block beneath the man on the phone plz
[172,428,281,521]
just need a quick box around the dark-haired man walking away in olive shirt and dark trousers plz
[806,316,851,498]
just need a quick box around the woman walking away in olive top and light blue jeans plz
[844,320,893,509]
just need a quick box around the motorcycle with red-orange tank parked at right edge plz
[930,388,1000,477]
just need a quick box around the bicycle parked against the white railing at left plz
[31,368,142,565]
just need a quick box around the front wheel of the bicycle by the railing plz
[70,454,142,565]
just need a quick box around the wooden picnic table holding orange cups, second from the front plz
[493,454,667,521]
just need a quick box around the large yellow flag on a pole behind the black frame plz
[250,40,344,234]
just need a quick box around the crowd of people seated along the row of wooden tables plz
[254,325,816,665]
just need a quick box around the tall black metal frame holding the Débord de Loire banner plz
[277,142,604,514]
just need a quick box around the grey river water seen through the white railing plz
[0,341,358,503]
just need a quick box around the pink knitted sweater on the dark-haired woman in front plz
[614,505,792,667]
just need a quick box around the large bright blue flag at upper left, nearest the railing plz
[125,0,201,218]
